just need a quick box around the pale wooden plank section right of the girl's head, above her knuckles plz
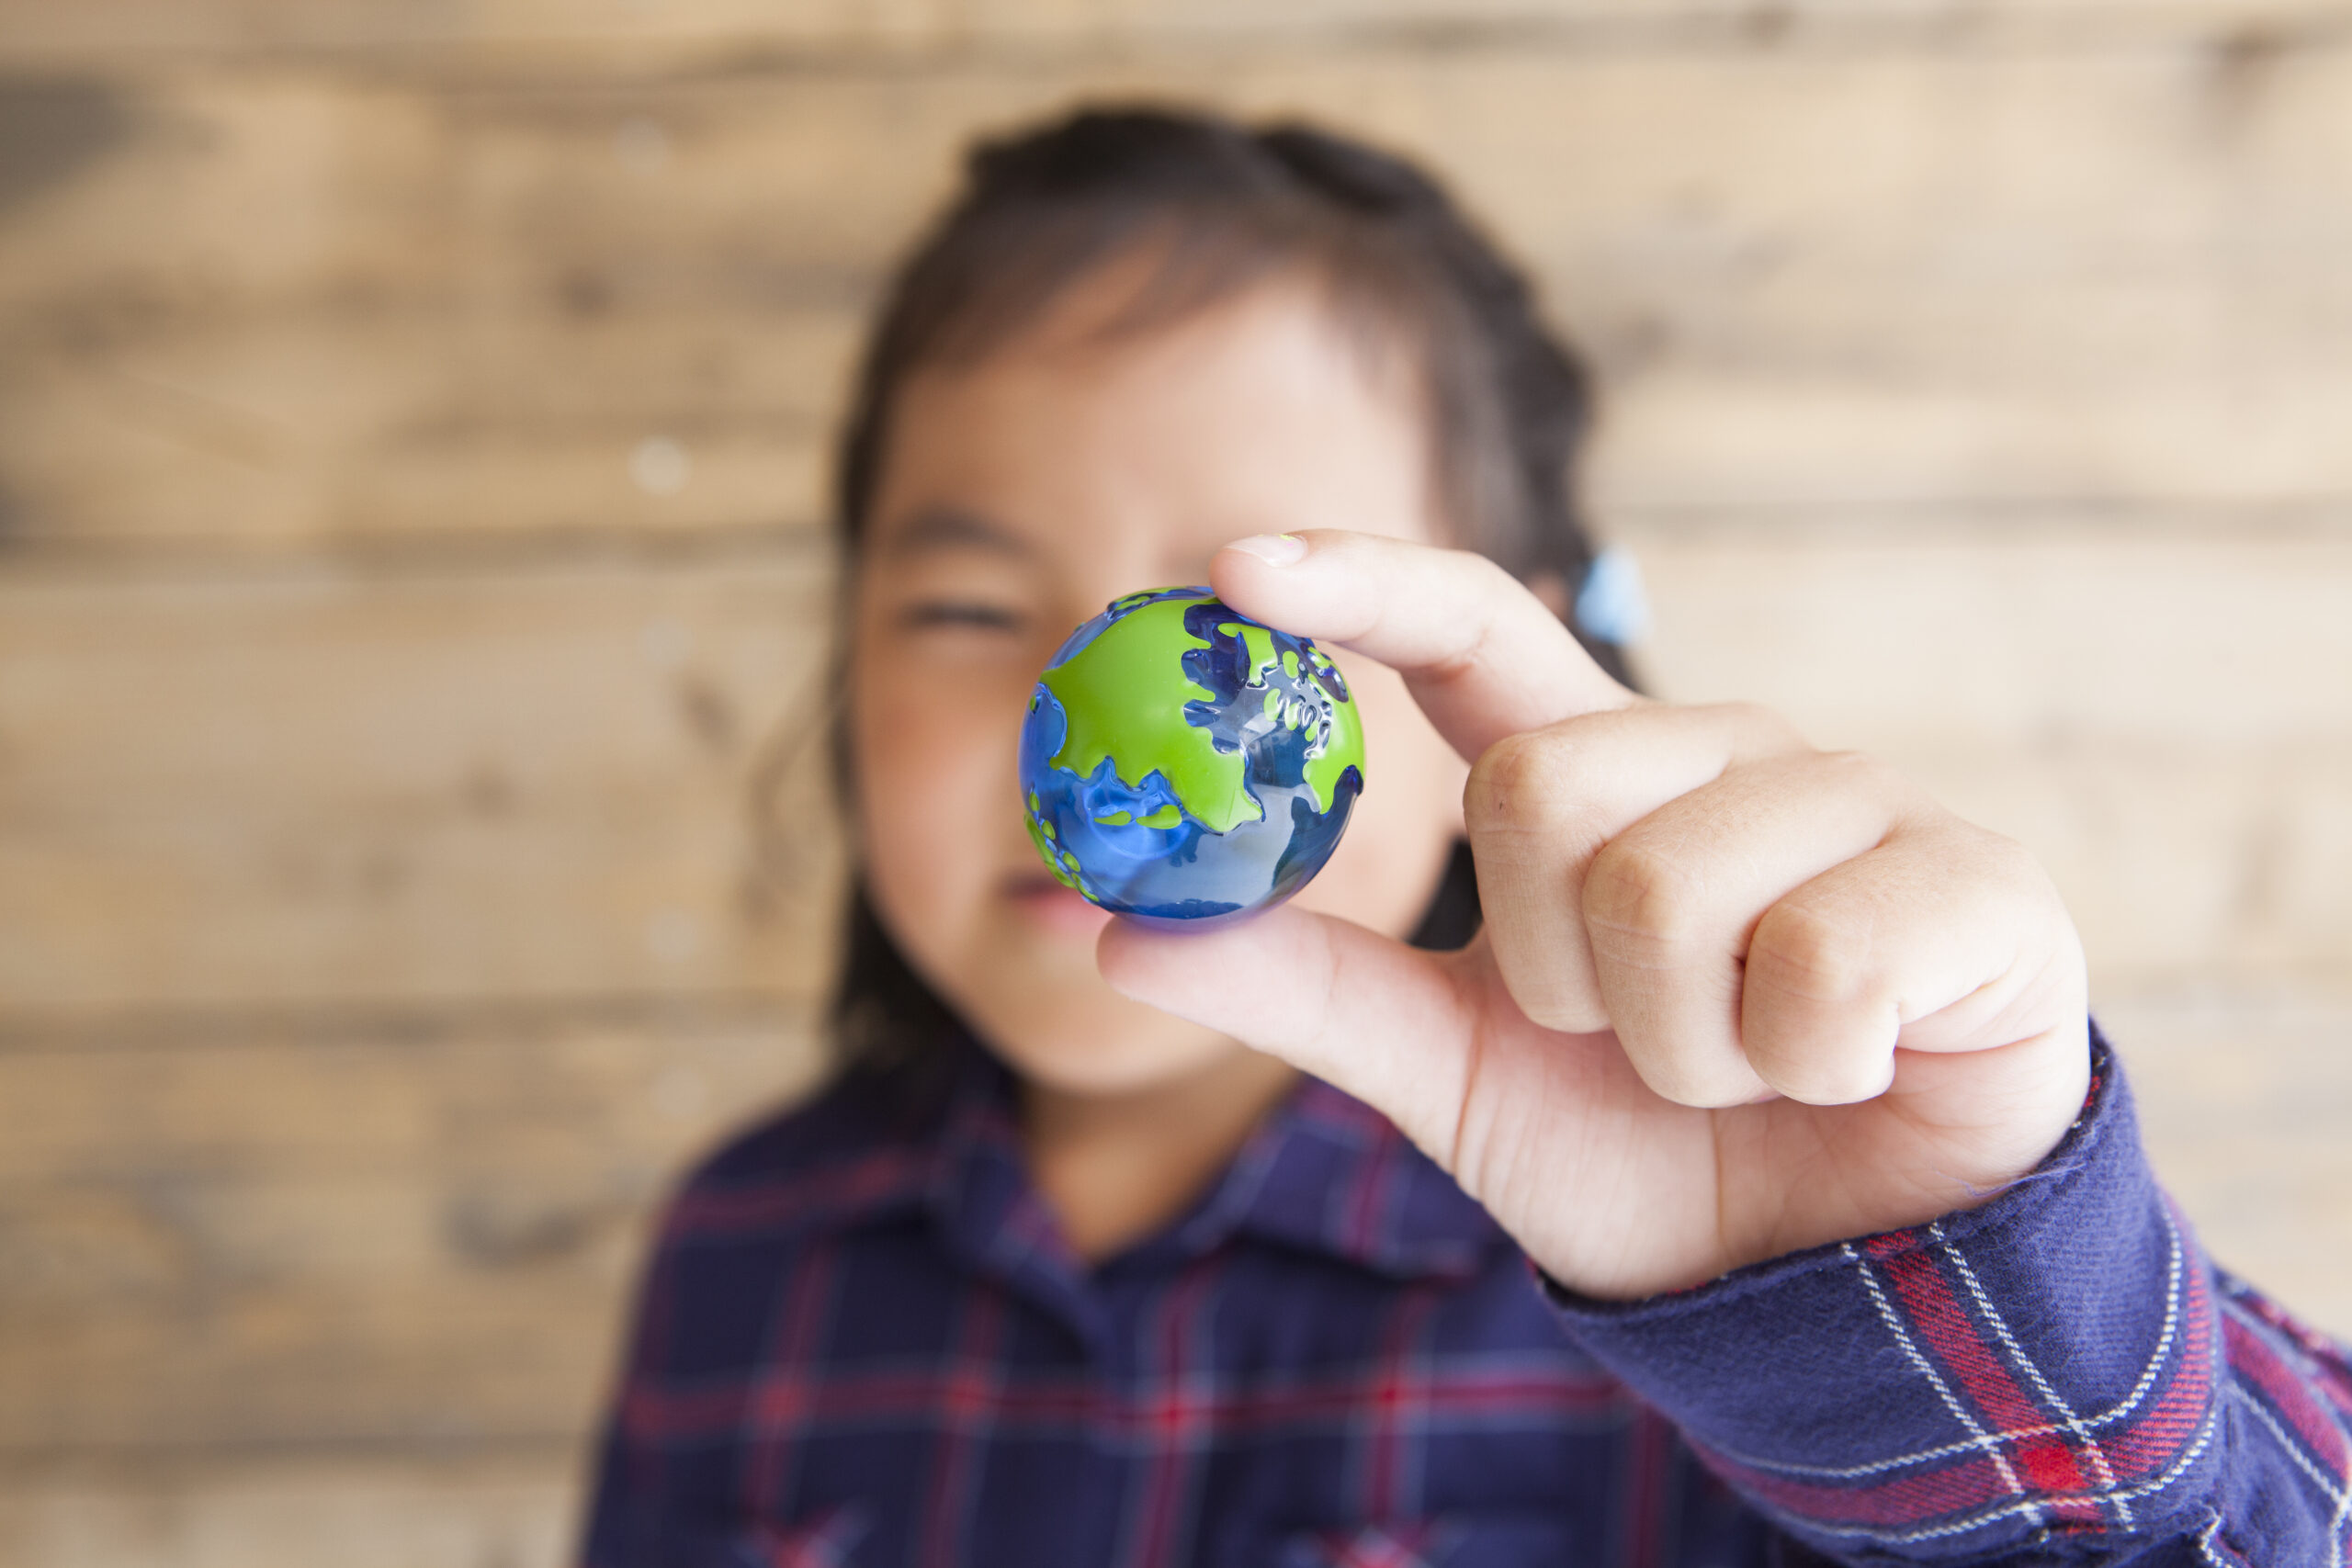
[1630,517,2352,997]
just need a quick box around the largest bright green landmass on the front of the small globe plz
[1040,597,1261,832]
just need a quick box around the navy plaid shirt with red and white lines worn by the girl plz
[583,1029,2352,1568]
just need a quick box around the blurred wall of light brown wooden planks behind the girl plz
[0,0,2352,1568]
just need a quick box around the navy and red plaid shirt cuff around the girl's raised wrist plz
[1545,1025,2218,1563]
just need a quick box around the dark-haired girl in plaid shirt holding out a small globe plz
[585,113,2352,1568]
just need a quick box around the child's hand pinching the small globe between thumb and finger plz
[1099,531,2088,1298]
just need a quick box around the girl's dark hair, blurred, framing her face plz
[831,108,1625,1067]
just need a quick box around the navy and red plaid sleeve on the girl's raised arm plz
[1550,1030,2352,1568]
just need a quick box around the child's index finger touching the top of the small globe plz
[1209,529,1642,761]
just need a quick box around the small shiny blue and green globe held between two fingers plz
[1021,588,1364,924]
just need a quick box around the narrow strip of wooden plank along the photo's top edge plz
[0,0,2340,63]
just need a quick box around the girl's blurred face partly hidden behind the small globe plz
[849,272,1465,1093]
